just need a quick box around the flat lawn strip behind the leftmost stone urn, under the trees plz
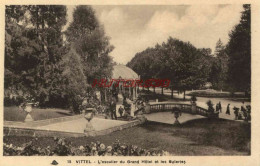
[4,106,72,122]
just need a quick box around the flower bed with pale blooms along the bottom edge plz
[4,138,170,156]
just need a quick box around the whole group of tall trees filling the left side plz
[5,5,113,111]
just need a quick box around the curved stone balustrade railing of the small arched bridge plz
[147,103,218,117]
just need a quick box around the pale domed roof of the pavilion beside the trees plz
[112,65,138,79]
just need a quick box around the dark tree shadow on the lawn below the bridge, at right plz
[142,119,251,154]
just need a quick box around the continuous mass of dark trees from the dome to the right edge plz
[127,5,251,96]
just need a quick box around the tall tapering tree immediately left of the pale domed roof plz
[66,6,114,84]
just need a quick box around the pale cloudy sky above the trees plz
[66,5,243,64]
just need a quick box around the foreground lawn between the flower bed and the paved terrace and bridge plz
[4,119,251,155]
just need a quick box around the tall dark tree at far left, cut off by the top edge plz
[5,5,67,105]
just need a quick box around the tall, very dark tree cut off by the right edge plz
[227,5,251,94]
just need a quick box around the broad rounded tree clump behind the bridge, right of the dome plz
[127,37,210,99]
